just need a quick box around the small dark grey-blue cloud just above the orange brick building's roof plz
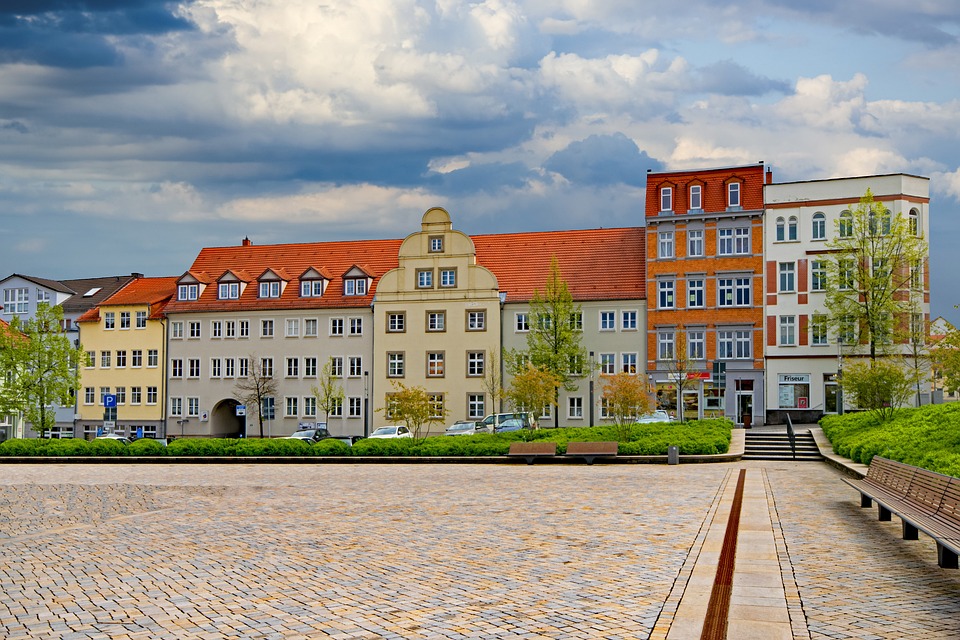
[544,133,663,187]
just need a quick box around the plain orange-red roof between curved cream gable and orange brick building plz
[472,227,646,302]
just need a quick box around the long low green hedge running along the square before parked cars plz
[0,419,733,457]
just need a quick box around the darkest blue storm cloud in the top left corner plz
[0,0,193,69]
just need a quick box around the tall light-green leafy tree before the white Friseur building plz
[825,189,927,360]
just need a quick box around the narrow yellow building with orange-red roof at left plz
[74,278,176,438]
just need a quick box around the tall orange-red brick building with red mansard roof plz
[645,163,772,424]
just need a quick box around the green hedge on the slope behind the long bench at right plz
[820,403,960,476]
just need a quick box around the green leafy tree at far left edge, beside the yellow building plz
[0,302,82,436]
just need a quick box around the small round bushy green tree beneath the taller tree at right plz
[842,357,914,422]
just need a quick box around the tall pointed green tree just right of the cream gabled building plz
[508,256,587,422]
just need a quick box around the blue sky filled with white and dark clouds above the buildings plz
[0,0,960,324]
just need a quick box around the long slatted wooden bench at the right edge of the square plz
[843,456,960,569]
